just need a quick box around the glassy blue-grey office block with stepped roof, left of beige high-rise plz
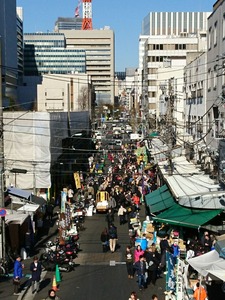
[24,33,86,76]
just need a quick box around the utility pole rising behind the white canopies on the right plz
[166,77,175,175]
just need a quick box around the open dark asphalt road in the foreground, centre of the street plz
[31,212,165,300]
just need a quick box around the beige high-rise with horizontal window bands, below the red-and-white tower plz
[59,27,115,105]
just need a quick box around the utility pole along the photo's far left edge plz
[0,37,6,262]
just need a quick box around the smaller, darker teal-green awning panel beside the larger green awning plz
[145,184,175,214]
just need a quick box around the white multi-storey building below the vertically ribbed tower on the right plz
[143,34,206,116]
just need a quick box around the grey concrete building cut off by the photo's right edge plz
[206,0,225,182]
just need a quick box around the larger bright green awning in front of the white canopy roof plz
[153,203,223,228]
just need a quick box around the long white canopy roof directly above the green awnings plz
[159,156,225,209]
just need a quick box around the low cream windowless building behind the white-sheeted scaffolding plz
[37,74,92,115]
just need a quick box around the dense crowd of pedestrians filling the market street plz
[11,137,214,300]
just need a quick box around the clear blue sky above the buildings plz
[17,0,216,71]
